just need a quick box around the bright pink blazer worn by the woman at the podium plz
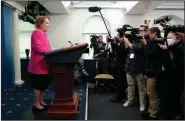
[28,29,52,74]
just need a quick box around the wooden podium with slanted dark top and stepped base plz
[45,44,88,119]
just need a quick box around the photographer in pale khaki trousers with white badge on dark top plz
[123,26,146,111]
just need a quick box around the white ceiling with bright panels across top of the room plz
[14,0,184,15]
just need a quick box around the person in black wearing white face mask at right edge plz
[159,32,184,120]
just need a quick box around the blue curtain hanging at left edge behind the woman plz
[1,3,15,89]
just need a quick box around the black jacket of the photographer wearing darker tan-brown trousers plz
[144,41,163,78]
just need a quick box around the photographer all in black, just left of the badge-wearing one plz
[111,37,128,102]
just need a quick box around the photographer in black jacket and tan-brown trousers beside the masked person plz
[142,27,162,119]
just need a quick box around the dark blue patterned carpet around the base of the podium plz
[1,84,86,120]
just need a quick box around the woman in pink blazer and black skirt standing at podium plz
[28,16,52,111]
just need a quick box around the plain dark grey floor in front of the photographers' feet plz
[88,89,141,120]
